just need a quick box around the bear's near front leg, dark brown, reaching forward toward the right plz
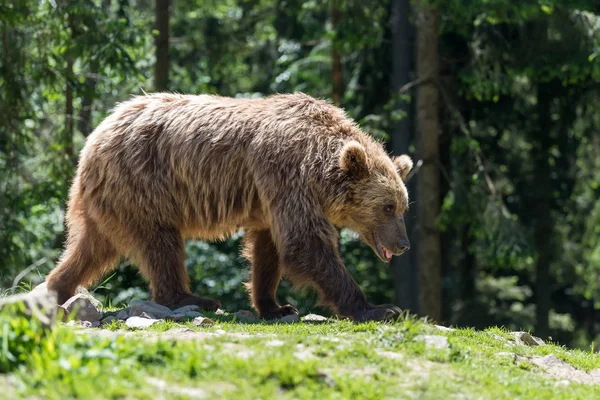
[280,221,401,322]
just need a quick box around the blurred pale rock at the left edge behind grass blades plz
[0,291,58,328]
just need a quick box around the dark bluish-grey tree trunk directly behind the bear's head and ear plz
[390,0,418,312]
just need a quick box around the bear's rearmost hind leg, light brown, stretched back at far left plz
[46,216,118,304]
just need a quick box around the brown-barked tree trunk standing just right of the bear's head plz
[416,3,441,320]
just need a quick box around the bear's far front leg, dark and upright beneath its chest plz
[244,229,298,319]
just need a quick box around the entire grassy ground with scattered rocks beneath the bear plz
[0,285,600,399]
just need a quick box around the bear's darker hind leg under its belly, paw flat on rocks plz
[138,228,221,310]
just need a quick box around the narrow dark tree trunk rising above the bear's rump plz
[154,0,169,91]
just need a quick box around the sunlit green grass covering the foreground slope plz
[0,314,600,400]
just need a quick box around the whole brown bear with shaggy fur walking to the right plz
[47,93,412,321]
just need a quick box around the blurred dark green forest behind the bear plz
[0,0,600,348]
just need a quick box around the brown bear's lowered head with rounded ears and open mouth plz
[339,141,413,262]
